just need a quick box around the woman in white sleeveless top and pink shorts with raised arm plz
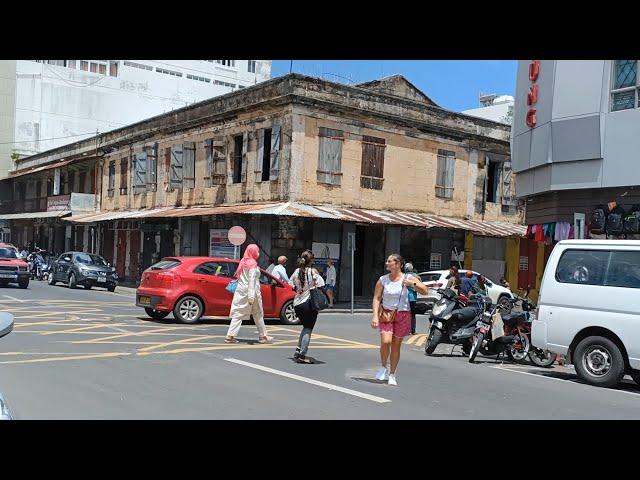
[371,253,428,385]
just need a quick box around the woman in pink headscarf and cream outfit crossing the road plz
[224,243,272,343]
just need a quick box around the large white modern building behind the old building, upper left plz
[0,60,271,178]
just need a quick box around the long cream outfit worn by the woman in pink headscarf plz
[227,268,267,337]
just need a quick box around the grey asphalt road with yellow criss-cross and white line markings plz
[0,282,640,420]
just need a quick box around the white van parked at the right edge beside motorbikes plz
[531,240,640,387]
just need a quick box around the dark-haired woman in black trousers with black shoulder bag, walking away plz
[289,250,324,363]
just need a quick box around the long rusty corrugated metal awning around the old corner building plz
[65,202,527,237]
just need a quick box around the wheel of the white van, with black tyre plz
[573,336,624,388]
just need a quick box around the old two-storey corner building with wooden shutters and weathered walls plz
[0,74,525,297]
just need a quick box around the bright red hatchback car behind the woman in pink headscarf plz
[136,257,300,325]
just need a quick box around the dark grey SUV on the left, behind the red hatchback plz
[49,252,118,292]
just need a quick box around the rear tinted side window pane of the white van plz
[556,250,611,285]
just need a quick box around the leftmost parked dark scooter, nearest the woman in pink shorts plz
[424,288,481,355]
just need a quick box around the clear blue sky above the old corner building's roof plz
[272,60,517,111]
